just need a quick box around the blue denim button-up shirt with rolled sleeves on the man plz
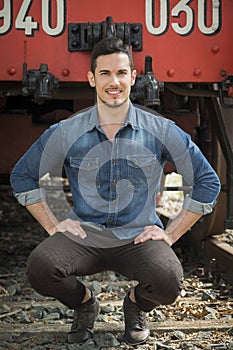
[11,104,220,239]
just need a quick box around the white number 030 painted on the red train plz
[145,0,221,36]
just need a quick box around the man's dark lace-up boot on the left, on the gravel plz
[68,293,99,343]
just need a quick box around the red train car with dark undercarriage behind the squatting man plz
[0,0,233,238]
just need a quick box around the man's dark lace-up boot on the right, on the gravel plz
[123,294,150,345]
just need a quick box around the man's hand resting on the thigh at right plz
[134,225,173,246]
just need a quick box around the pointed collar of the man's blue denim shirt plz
[88,102,139,131]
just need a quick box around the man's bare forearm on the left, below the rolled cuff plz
[26,201,58,235]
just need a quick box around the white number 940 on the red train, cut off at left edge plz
[0,0,66,36]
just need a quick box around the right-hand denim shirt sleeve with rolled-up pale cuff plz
[166,124,221,215]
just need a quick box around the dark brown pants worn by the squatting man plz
[27,233,183,311]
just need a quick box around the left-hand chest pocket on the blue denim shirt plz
[70,157,100,189]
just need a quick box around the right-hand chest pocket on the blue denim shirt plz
[127,155,161,189]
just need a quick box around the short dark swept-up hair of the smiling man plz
[91,37,134,73]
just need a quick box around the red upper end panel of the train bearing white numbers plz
[0,0,233,83]
